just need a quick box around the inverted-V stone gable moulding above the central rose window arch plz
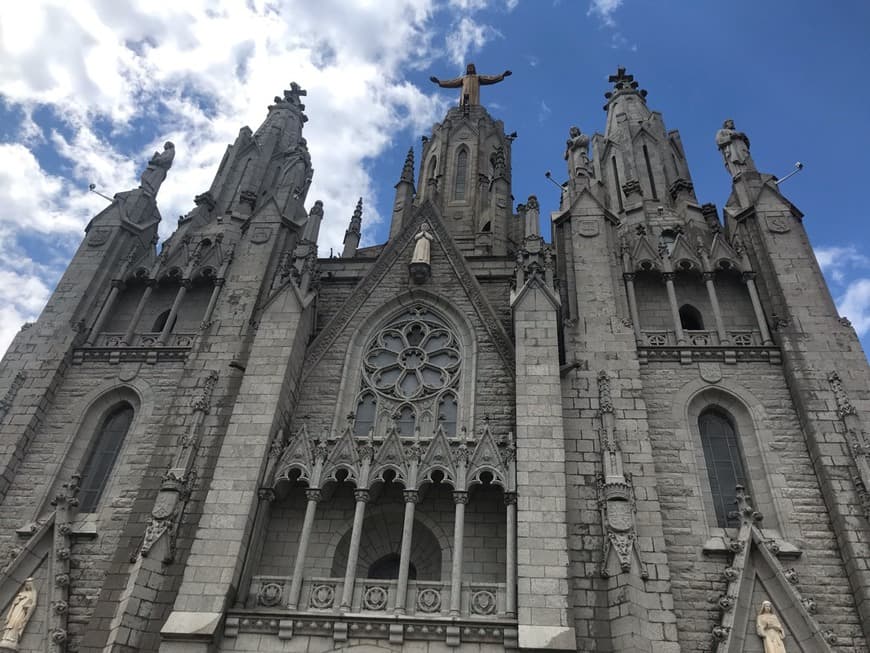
[303,201,514,376]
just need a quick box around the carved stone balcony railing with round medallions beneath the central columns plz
[245,576,506,618]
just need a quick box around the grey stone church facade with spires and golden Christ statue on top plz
[0,66,870,653]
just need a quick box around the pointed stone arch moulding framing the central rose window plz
[332,288,477,433]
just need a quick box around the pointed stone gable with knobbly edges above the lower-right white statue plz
[713,486,831,653]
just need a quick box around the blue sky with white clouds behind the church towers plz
[0,0,870,352]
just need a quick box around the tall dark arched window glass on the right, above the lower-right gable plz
[698,410,746,528]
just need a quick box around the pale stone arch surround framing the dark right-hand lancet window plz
[672,379,785,534]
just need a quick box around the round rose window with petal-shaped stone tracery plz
[363,309,460,400]
